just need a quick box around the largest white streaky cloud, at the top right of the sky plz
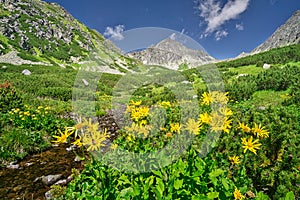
[196,0,250,33]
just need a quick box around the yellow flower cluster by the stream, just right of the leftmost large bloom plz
[82,129,109,151]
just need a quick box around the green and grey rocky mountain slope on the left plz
[0,0,137,73]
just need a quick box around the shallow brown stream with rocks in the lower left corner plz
[0,144,84,200]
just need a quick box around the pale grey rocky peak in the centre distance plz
[129,38,215,69]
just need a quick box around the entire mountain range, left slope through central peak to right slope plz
[0,0,300,74]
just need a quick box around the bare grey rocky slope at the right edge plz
[251,10,300,53]
